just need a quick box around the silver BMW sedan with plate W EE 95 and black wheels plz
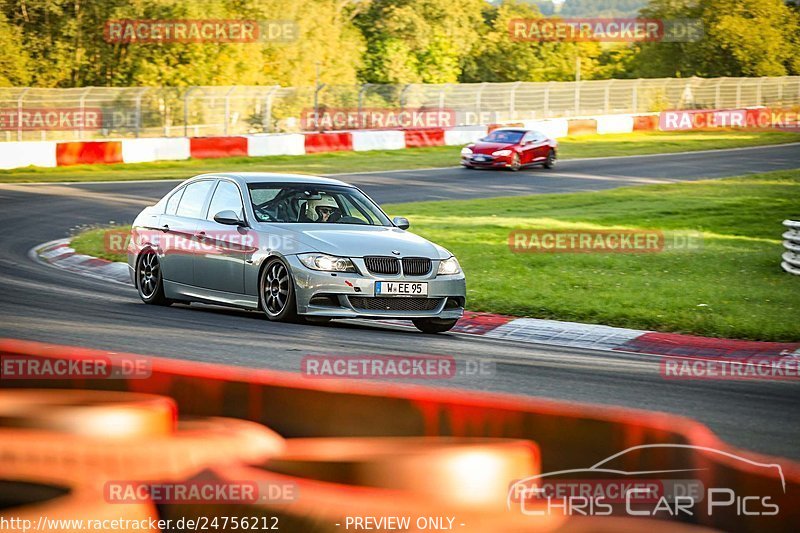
[128,173,466,333]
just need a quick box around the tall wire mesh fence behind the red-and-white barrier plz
[0,76,800,141]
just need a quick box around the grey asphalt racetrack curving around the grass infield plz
[0,144,800,460]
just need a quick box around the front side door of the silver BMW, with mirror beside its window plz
[194,179,248,294]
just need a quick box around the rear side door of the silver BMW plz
[159,179,214,285]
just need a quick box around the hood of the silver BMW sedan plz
[266,224,452,259]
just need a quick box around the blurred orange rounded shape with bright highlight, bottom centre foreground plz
[264,437,540,511]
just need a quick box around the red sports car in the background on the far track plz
[461,128,558,171]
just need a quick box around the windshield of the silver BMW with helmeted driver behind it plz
[249,183,392,226]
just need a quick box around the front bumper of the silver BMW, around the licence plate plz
[285,256,467,319]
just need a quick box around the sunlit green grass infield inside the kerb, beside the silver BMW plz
[73,171,800,341]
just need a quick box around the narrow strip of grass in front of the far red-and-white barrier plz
[0,130,800,183]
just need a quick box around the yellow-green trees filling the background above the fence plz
[0,0,800,86]
